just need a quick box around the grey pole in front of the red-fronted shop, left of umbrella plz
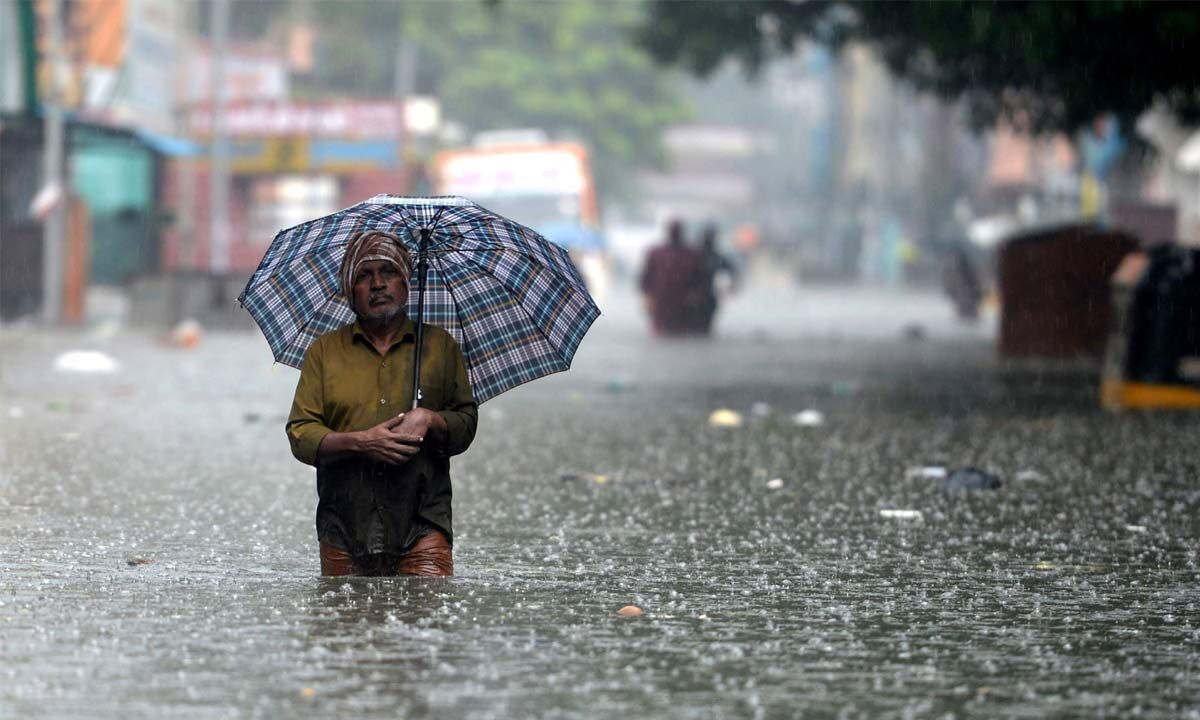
[209,0,229,275]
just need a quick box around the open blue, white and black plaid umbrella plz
[238,194,600,402]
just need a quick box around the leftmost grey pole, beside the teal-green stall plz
[42,0,67,325]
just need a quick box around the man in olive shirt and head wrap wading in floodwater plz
[287,230,478,575]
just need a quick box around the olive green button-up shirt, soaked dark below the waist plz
[287,318,479,557]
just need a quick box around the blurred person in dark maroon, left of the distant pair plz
[638,220,712,337]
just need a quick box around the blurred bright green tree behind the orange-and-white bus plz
[304,0,689,197]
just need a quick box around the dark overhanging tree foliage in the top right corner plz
[636,0,1200,132]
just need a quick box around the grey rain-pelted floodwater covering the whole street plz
[0,284,1200,719]
